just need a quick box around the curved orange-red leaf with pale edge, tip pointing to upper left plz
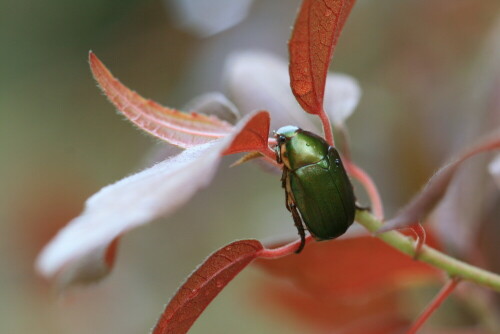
[89,52,232,148]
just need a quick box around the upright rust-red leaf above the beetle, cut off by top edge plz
[288,0,355,114]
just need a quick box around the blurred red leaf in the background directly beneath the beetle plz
[257,236,438,295]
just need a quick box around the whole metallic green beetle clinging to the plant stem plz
[275,126,357,253]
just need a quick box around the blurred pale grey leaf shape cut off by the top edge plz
[168,0,252,37]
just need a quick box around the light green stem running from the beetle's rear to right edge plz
[356,210,500,292]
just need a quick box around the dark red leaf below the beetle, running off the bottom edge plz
[153,240,263,334]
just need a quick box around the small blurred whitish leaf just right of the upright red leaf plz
[324,73,361,125]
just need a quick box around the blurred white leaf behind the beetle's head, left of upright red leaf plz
[224,51,318,132]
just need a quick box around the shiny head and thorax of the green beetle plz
[277,127,329,171]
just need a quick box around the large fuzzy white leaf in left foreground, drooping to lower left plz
[36,112,268,283]
